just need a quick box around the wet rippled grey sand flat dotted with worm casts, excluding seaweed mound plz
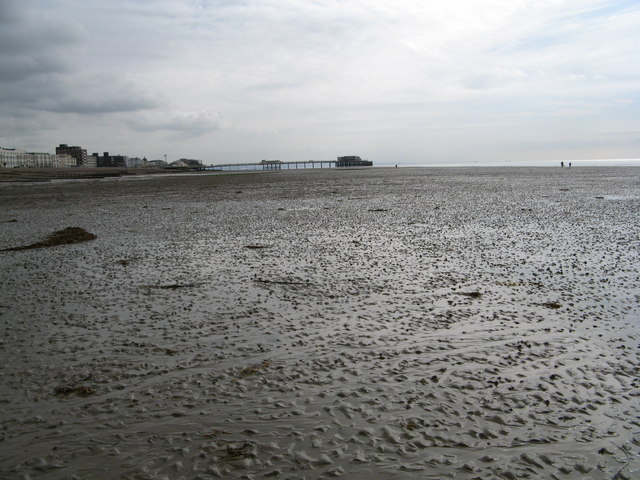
[0,167,640,480]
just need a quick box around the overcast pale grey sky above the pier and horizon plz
[0,0,640,164]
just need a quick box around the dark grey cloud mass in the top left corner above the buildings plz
[0,0,157,114]
